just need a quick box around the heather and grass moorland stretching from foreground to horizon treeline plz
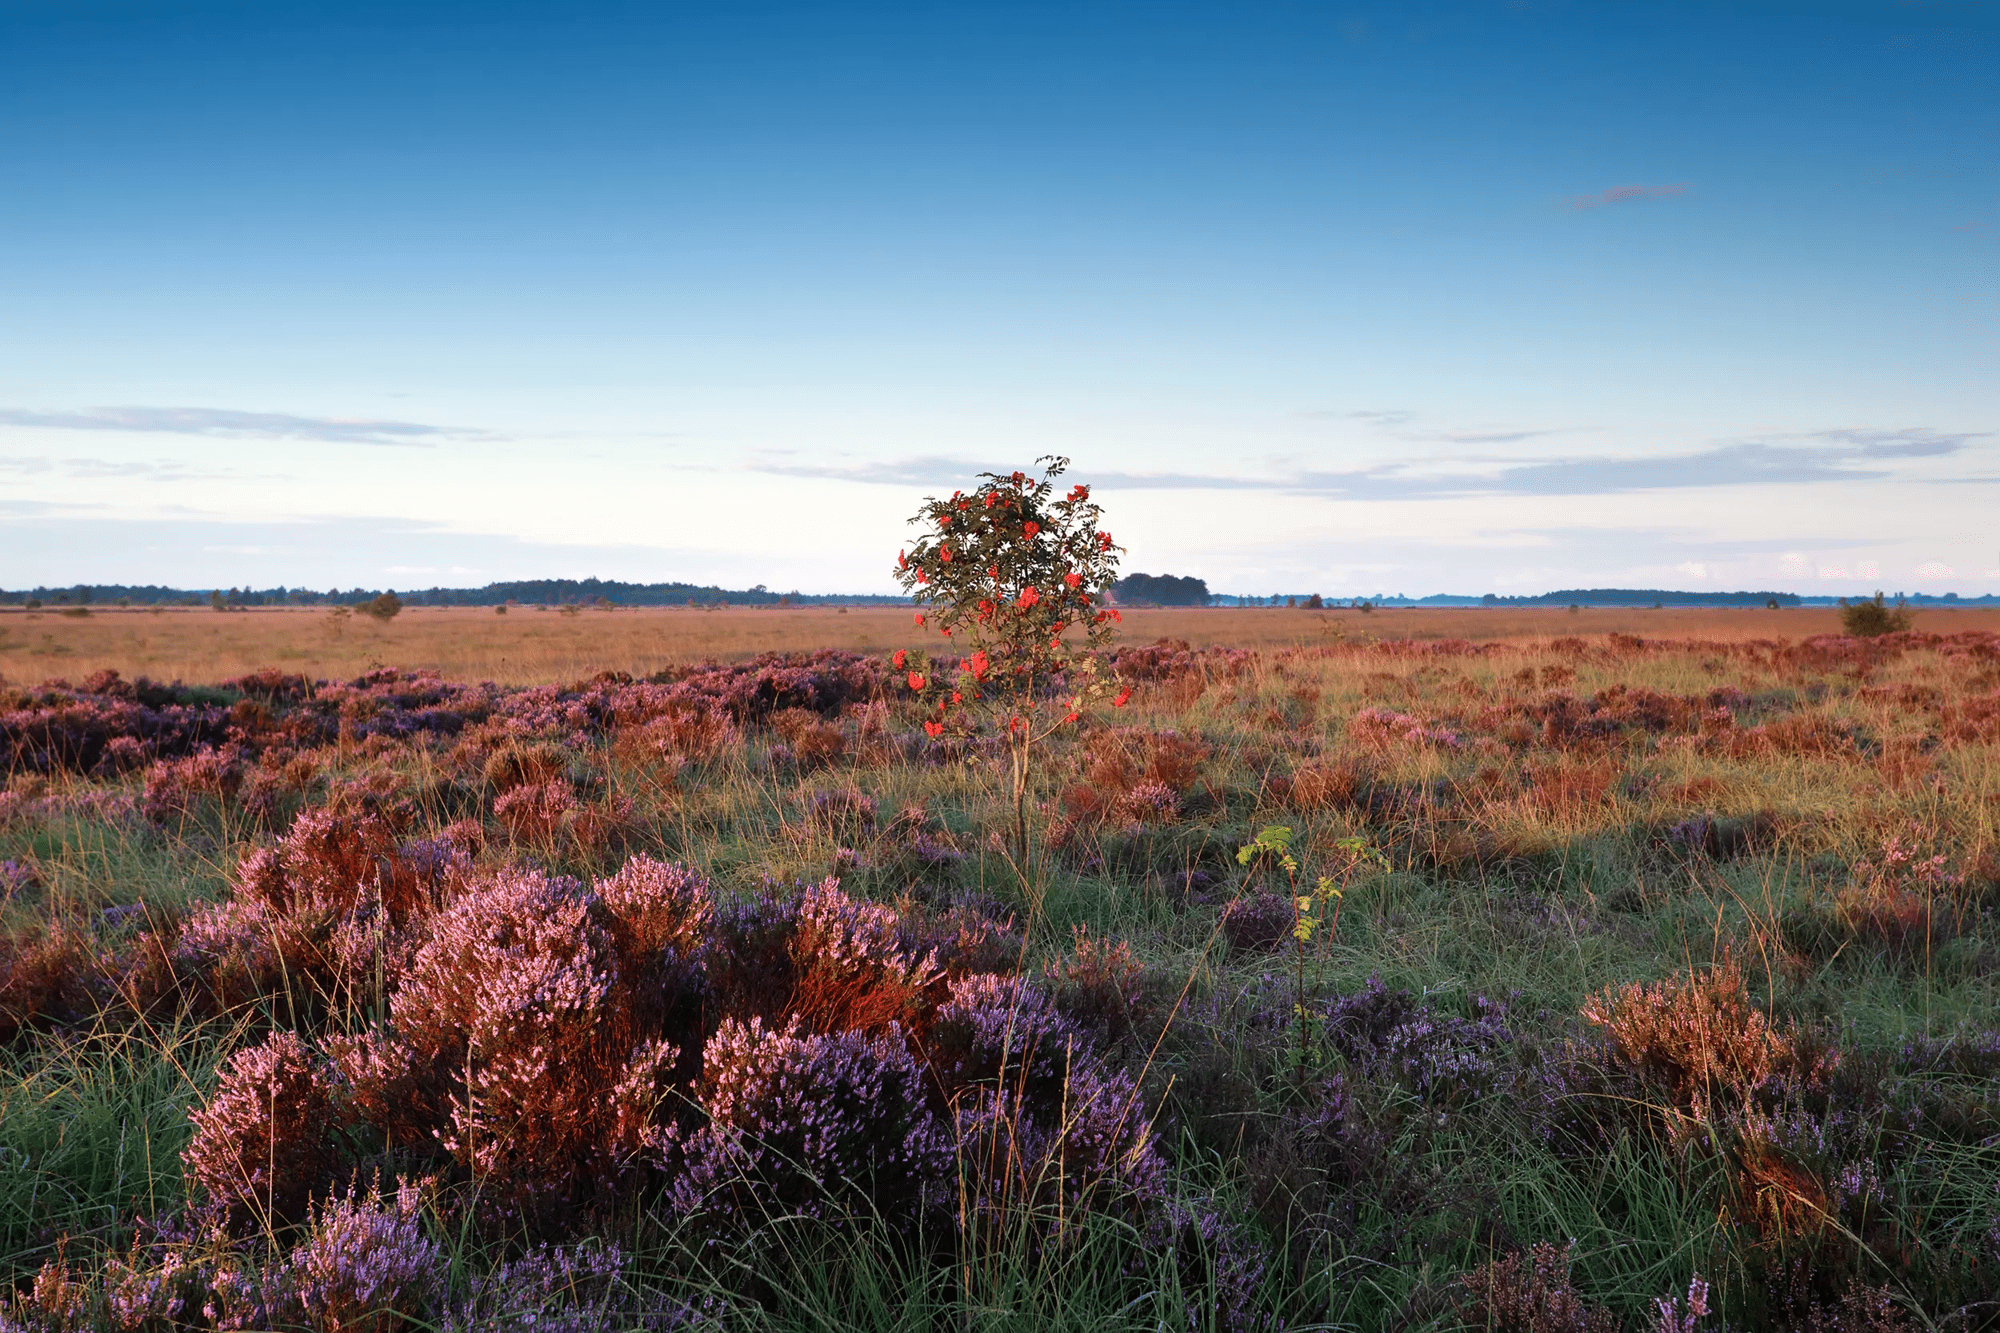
[0,606,2000,1333]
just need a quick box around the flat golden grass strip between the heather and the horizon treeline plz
[0,606,2000,685]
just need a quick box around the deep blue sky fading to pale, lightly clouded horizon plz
[0,0,2000,594]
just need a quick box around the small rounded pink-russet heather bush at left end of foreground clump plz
[182,1033,342,1225]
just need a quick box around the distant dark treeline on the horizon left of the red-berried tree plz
[0,578,908,606]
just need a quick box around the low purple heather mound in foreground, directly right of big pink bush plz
[674,1019,952,1225]
